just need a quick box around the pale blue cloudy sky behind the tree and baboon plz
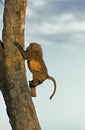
[0,0,85,130]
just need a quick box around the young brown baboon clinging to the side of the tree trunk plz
[13,42,56,99]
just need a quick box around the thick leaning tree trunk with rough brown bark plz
[0,0,41,130]
